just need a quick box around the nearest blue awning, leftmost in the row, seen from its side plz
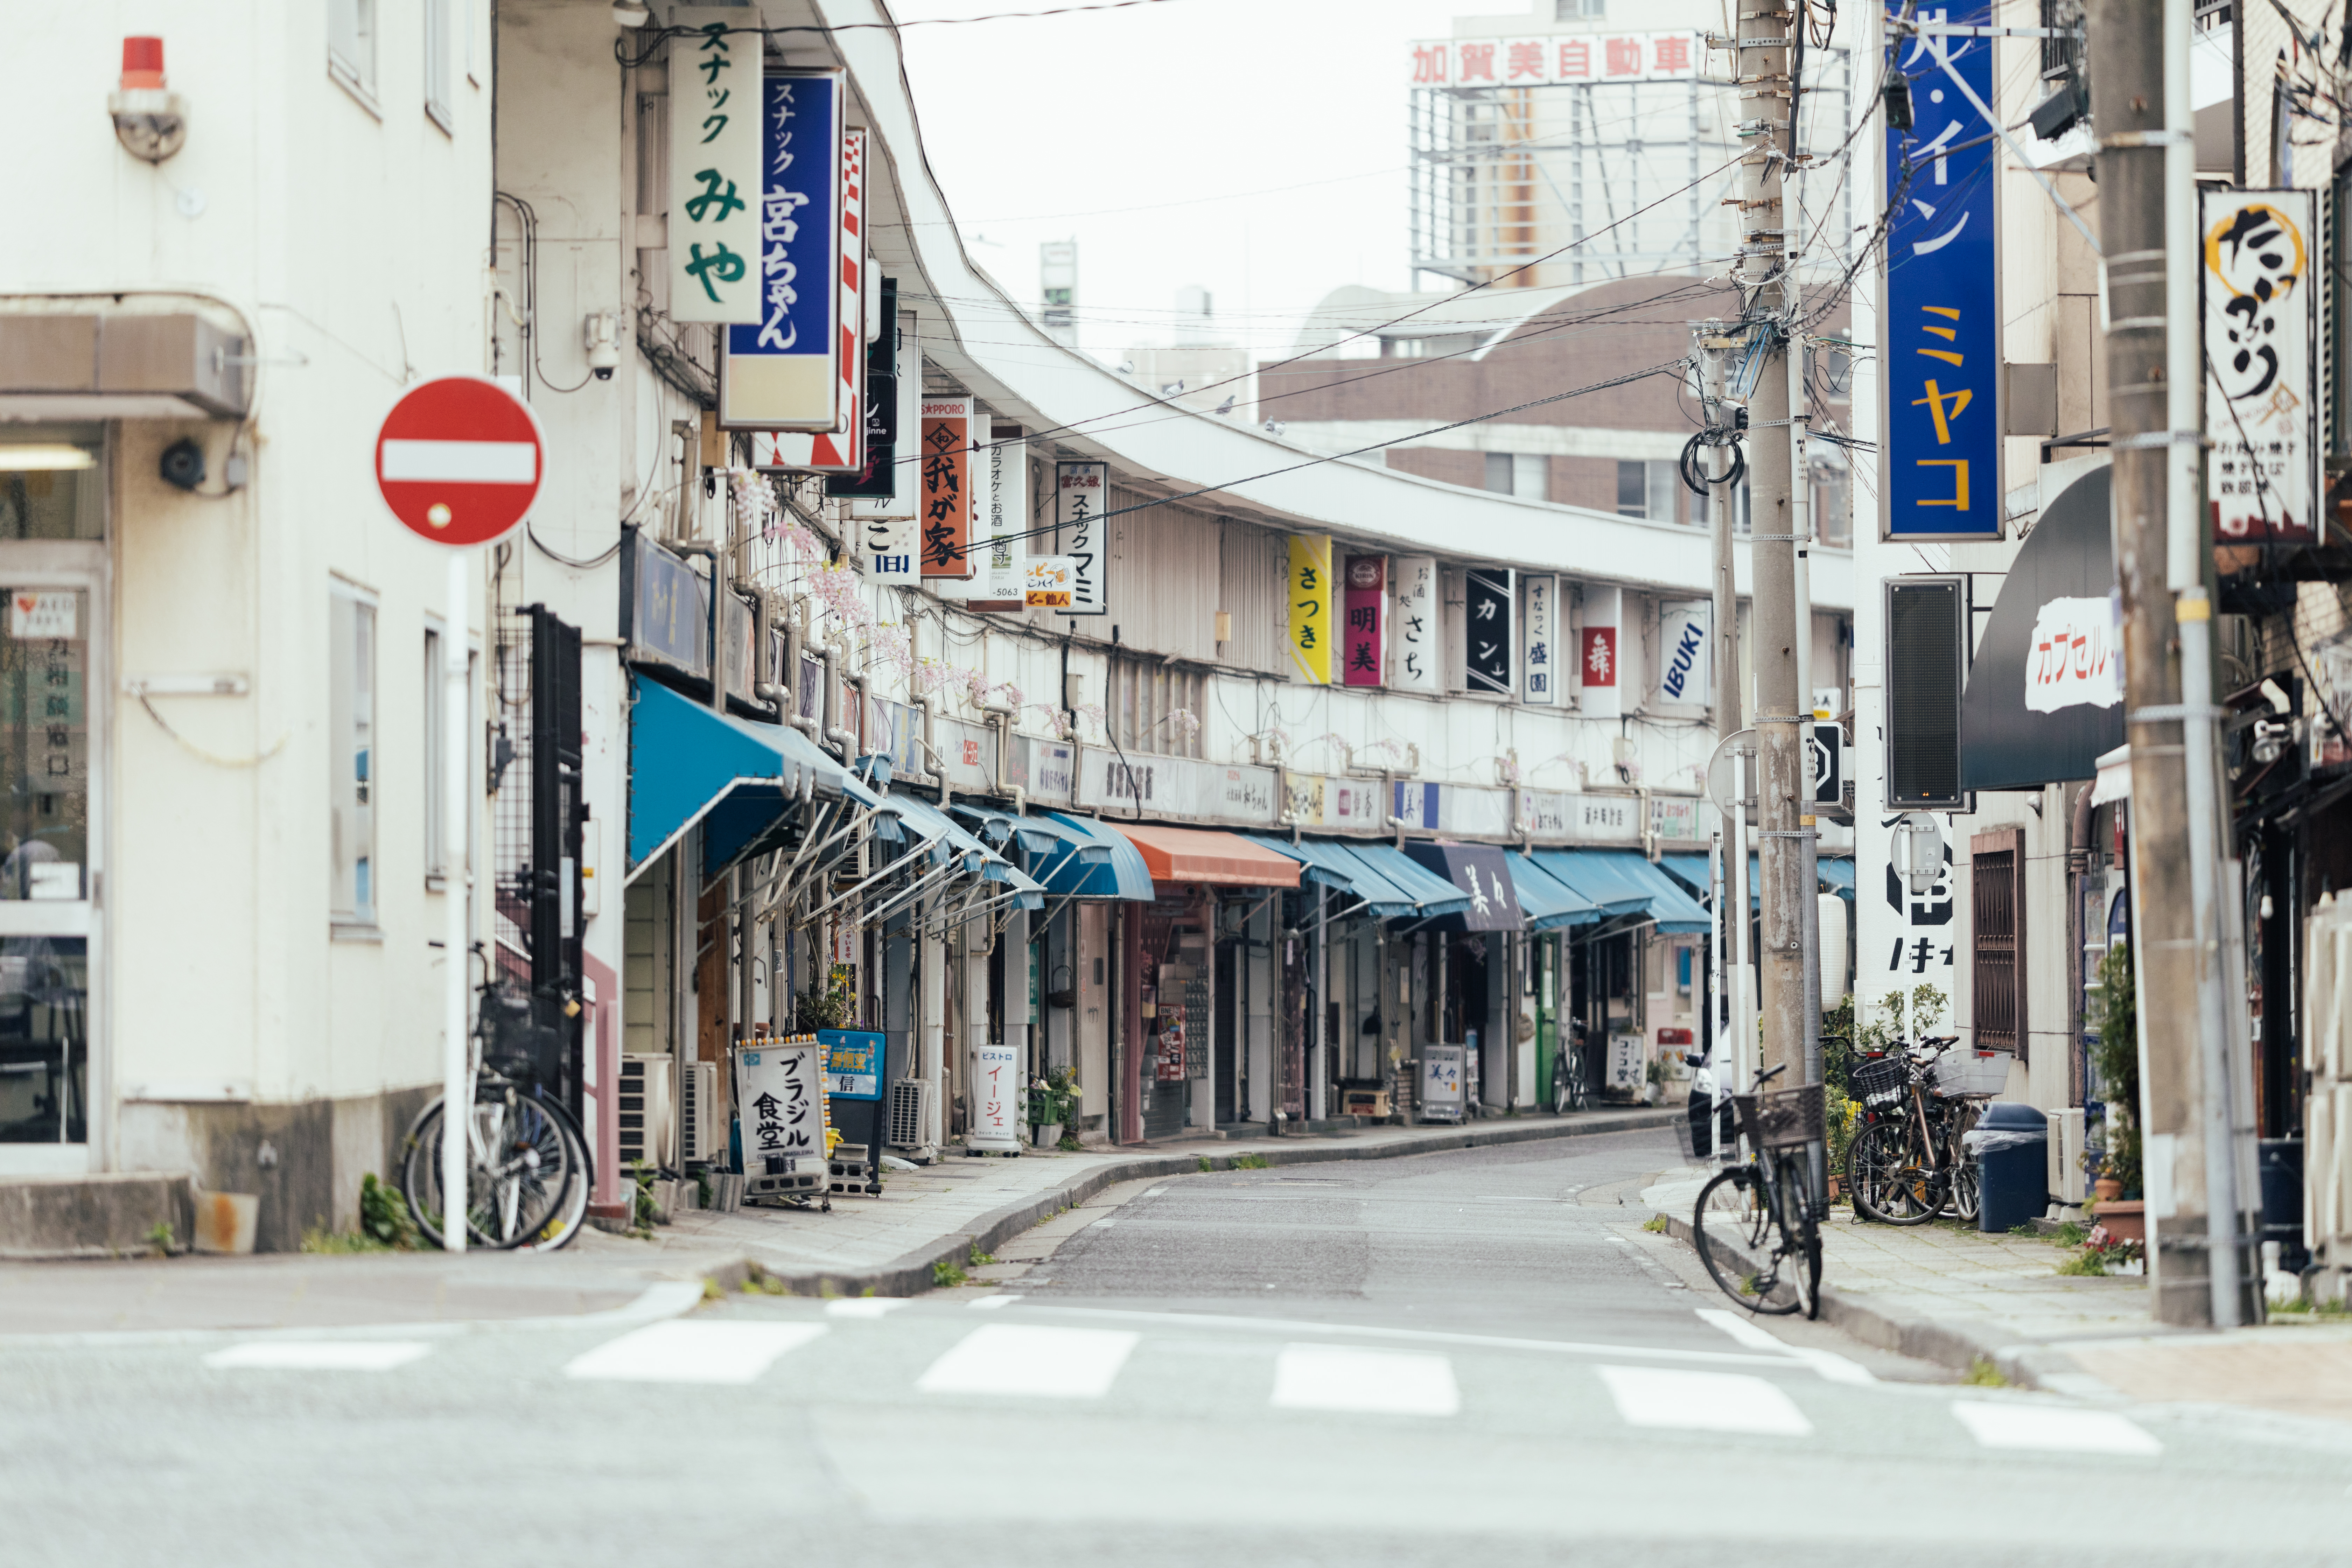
[628,677,877,875]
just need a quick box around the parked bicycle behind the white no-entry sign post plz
[400,980,593,1251]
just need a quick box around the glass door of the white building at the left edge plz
[0,585,101,1171]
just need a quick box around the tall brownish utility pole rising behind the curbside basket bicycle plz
[1736,0,1813,1105]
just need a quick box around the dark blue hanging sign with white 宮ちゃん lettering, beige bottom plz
[715,70,847,425]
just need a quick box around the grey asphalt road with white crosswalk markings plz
[0,1133,2352,1568]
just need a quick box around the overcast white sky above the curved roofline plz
[891,0,1496,362]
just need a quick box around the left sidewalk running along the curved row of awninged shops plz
[0,1107,1682,1340]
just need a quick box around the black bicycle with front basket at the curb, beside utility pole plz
[1691,1065,1825,1316]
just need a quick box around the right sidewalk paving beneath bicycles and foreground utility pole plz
[1642,1166,2352,1420]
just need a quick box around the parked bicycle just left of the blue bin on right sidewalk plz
[1846,1034,1983,1225]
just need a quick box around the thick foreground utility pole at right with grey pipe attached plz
[2088,0,2255,1328]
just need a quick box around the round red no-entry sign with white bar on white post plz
[376,376,548,545]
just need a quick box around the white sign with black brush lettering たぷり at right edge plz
[2197,186,2322,545]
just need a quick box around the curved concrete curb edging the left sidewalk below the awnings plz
[701,1107,1684,1295]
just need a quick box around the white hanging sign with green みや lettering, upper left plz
[670,5,767,324]
